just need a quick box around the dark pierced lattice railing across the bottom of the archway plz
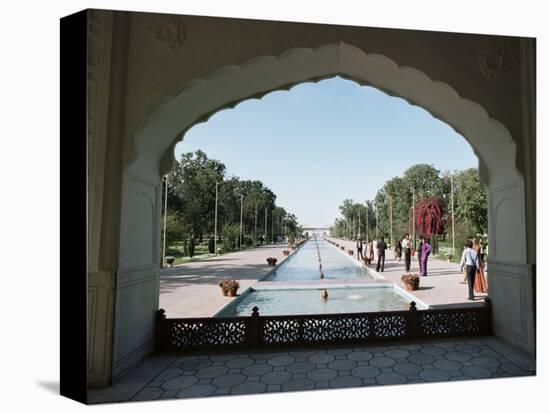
[156,299,491,352]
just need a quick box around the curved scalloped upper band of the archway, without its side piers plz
[127,42,521,186]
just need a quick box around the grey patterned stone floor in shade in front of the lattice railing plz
[89,337,535,403]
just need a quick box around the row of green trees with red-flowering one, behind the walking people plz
[331,164,487,247]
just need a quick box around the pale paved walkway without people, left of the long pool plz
[159,244,290,318]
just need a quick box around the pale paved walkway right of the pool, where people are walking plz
[329,238,487,308]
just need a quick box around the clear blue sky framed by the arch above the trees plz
[176,78,477,225]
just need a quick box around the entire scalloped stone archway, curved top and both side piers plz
[113,43,534,377]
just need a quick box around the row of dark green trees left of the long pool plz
[162,150,301,250]
